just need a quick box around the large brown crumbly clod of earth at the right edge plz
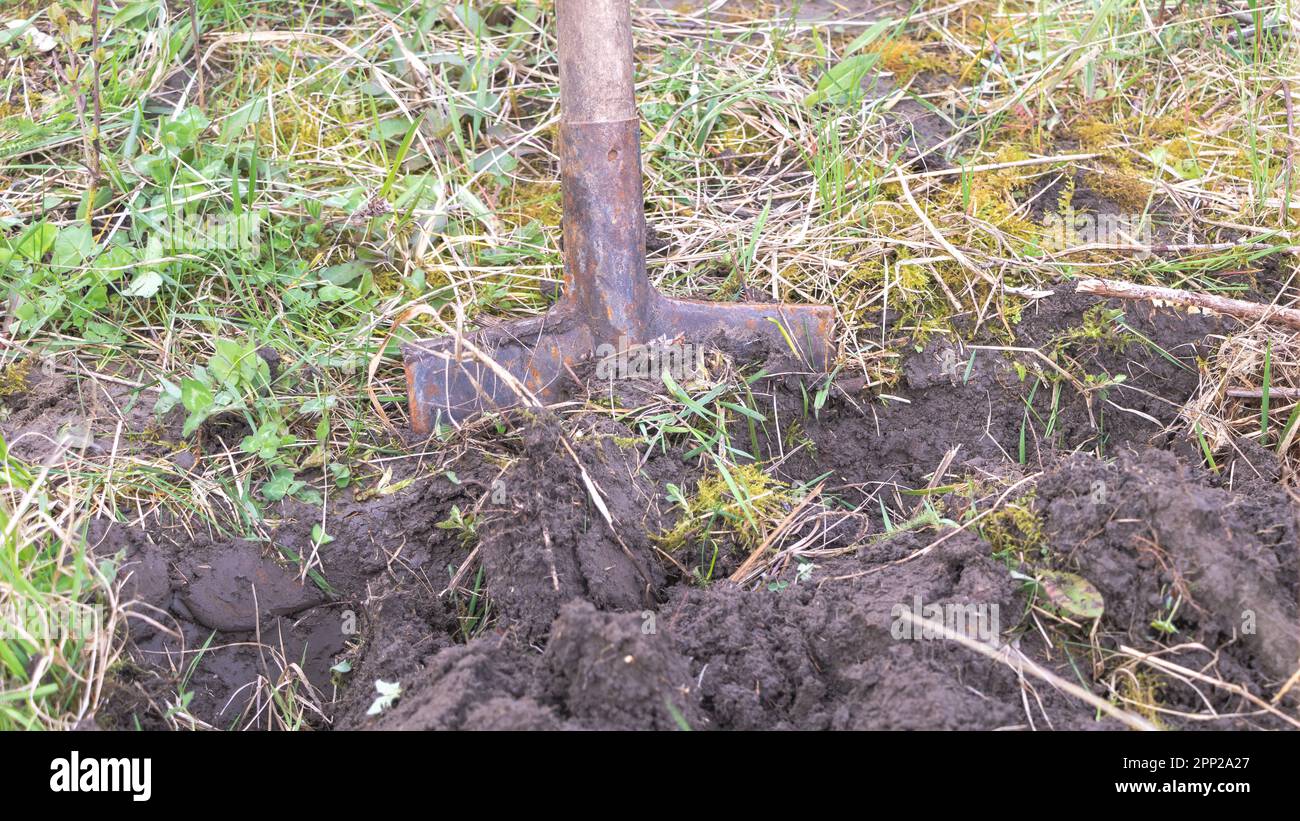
[1037,451,1300,688]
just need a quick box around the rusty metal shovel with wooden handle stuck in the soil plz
[402,0,835,434]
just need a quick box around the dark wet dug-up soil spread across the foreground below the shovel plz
[0,286,1300,729]
